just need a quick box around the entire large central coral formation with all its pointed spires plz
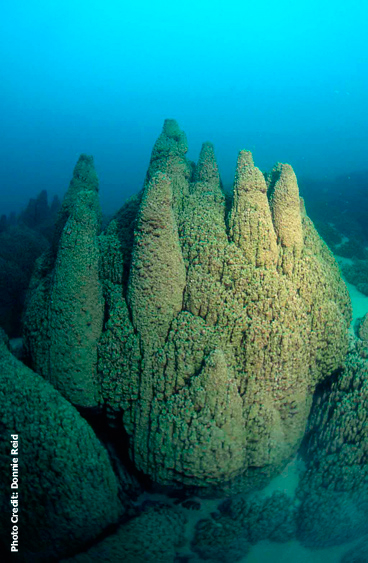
[25,120,351,494]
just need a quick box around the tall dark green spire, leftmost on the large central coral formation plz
[25,155,104,407]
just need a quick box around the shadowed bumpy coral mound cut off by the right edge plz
[297,334,368,547]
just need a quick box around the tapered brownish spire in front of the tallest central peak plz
[127,172,185,348]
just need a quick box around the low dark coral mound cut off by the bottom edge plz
[62,506,185,563]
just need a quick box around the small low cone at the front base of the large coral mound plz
[145,350,246,484]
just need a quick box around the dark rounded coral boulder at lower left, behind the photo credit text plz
[0,328,124,561]
